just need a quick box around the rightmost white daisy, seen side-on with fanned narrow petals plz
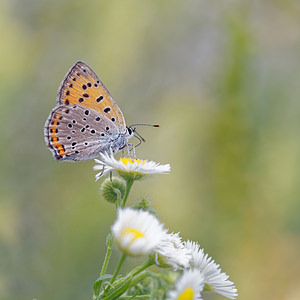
[185,241,237,299]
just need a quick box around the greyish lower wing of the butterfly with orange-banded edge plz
[45,105,123,161]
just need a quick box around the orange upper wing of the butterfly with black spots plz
[57,61,126,132]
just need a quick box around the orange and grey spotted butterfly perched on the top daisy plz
[44,61,134,161]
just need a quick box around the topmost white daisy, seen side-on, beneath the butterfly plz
[94,153,171,181]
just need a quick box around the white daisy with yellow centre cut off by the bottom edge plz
[167,270,204,300]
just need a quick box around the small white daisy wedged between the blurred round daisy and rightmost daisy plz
[155,232,192,271]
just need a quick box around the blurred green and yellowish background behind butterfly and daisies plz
[0,0,300,300]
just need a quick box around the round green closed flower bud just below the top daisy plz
[100,177,126,203]
